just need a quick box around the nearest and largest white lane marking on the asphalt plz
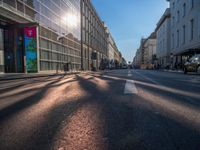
[124,80,138,94]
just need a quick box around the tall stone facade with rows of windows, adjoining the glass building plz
[81,0,108,70]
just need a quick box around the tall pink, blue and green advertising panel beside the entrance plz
[24,27,38,73]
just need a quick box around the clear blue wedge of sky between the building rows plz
[91,0,169,61]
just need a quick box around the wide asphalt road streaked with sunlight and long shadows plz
[0,70,200,150]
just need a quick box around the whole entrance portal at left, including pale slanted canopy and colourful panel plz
[0,6,39,73]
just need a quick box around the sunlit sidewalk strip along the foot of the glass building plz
[0,71,81,81]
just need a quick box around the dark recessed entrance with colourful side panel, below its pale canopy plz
[0,24,38,73]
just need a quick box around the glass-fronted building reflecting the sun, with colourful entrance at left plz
[0,0,81,73]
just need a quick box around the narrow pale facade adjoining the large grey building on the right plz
[156,8,171,68]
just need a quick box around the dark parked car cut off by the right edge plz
[183,54,200,74]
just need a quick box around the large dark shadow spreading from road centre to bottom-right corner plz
[54,76,200,150]
